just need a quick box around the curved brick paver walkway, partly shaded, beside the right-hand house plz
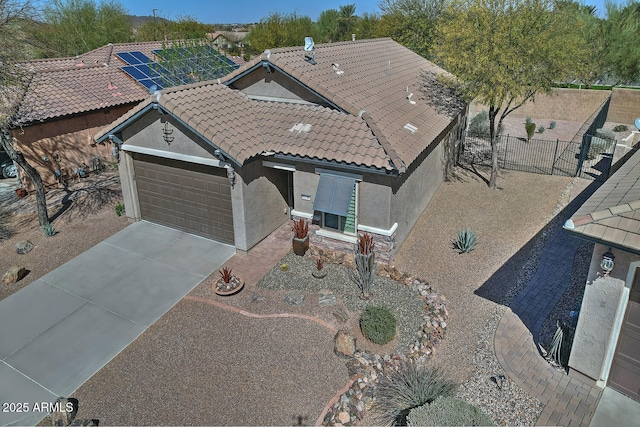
[494,182,602,426]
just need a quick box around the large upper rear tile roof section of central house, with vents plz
[222,38,462,170]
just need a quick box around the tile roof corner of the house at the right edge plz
[564,150,640,255]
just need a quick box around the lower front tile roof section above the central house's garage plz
[95,82,391,170]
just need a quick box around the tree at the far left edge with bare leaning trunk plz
[0,0,49,227]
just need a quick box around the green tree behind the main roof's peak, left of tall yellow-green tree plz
[379,0,447,59]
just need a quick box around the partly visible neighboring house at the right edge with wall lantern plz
[564,151,640,401]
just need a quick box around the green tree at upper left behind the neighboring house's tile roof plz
[33,0,132,57]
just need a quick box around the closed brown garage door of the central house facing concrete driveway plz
[133,154,234,244]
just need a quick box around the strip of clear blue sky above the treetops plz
[120,0,626,24]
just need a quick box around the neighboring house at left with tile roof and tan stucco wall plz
[7,42,244,189]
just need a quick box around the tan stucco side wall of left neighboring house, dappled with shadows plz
[12,105,132,190]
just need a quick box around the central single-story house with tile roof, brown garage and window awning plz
[95,39,466,260]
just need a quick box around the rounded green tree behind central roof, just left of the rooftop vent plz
[247,13,317,53]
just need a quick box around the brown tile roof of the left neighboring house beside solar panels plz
[19,42,244,124]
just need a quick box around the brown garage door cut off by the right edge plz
[609,269,640,401]
